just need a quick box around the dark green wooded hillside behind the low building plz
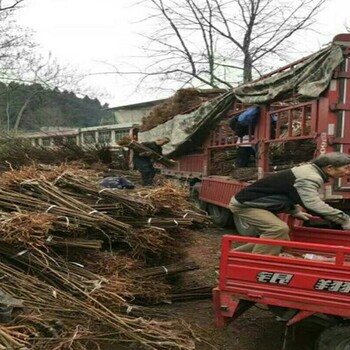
[0,82,110,131]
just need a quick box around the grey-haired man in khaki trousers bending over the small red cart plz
[229,152,350,255]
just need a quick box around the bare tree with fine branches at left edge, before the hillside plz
[0,6,101,133]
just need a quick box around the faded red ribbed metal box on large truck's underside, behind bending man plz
[200,177,248,208]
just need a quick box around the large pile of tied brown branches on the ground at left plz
[0,164,208,350]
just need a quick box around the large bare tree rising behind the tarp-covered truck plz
[133,0,326,87]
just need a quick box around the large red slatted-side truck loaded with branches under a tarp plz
[162,34,350,233]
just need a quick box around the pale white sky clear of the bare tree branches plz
[16,0,350,107]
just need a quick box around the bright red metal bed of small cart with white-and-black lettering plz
[213,227,350,327]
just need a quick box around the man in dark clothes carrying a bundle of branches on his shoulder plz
[133,137,170,186]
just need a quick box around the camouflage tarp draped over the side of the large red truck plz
[139,44,344,156]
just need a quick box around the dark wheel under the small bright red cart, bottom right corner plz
[316,325,350,350]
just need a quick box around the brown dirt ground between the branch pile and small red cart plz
[104,228,326,350]
